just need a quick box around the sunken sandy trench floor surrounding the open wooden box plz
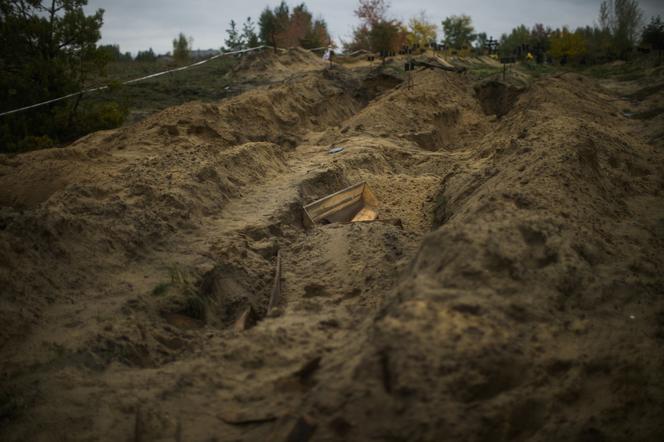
[113,67,482,440]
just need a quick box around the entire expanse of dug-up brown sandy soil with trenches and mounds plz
[0,52,664,441]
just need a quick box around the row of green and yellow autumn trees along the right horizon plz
[344,0,664,63]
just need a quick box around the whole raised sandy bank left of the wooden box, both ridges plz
[0,65,374,340]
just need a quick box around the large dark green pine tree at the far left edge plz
[0,0,119,152]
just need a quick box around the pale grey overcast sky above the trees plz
[87,0,664,53]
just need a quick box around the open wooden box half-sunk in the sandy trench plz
[303,182,378,227]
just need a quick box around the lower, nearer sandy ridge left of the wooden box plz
[0,143,286,345]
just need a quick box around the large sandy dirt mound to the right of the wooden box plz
[304,74,664,440]
